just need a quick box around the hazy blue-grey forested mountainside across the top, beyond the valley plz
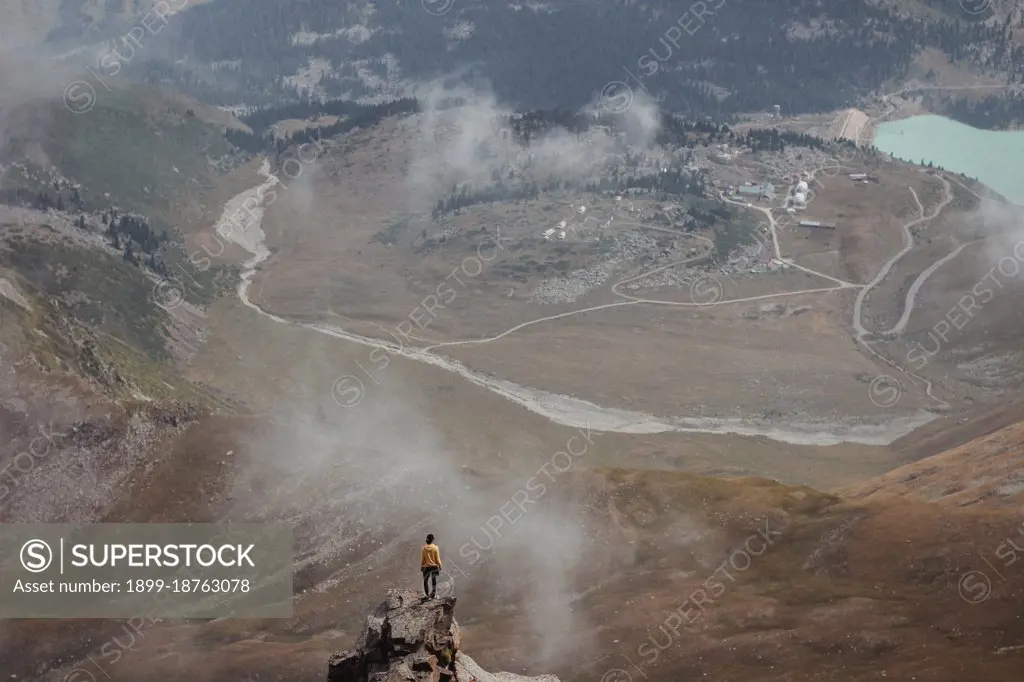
[24,0,1024,117]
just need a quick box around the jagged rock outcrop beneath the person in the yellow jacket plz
[328,590,558,682]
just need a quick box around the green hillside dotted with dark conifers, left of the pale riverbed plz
[0,87,247,402]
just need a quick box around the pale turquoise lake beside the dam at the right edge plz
[873,116,1024,205]
